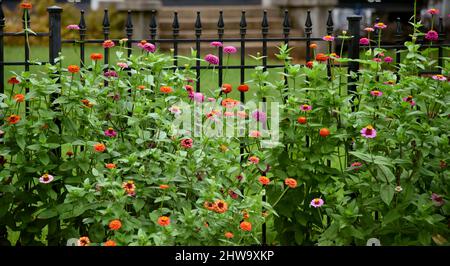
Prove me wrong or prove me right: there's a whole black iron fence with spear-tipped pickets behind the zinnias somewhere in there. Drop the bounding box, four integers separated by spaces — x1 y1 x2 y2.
0 2 449 244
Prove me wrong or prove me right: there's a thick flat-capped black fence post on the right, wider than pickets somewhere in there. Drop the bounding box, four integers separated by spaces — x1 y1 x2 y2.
347 16 362 107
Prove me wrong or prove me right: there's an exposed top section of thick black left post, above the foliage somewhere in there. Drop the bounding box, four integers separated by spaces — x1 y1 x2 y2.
47 6 62 65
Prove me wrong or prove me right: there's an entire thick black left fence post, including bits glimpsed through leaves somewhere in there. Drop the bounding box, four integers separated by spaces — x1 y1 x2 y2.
47 6 62 246
